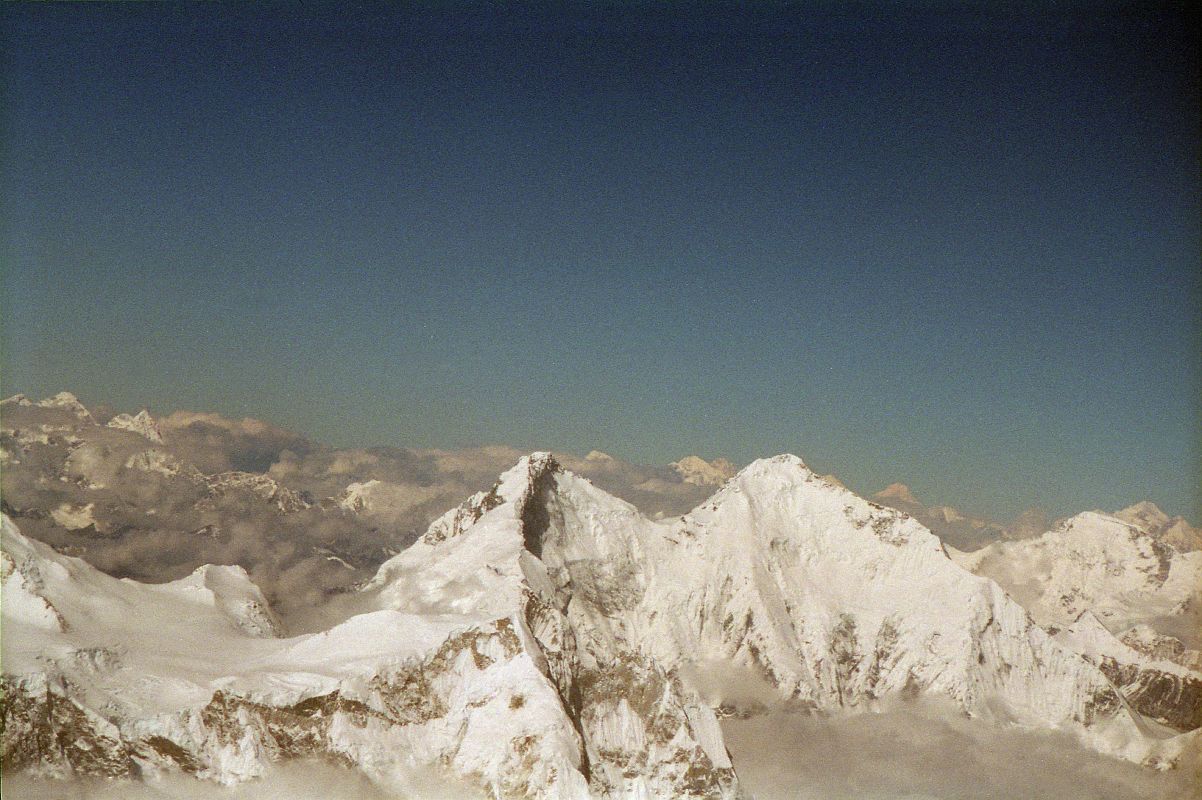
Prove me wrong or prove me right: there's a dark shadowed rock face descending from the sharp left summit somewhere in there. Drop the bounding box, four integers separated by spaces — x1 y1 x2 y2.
519 468 738 798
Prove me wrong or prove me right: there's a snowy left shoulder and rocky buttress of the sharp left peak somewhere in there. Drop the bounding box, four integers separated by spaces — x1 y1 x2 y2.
4 460 737 798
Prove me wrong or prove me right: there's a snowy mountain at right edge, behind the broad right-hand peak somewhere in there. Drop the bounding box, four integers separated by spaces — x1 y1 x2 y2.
950 502 1202 730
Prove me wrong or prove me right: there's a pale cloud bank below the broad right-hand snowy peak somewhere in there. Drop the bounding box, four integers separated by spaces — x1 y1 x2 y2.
722 700 1202 800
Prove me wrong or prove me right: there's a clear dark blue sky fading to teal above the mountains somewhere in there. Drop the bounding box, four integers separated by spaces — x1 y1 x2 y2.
0 2 1202 521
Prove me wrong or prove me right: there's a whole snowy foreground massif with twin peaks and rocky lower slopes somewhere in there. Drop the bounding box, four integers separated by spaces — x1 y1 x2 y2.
2 453 1200 799
